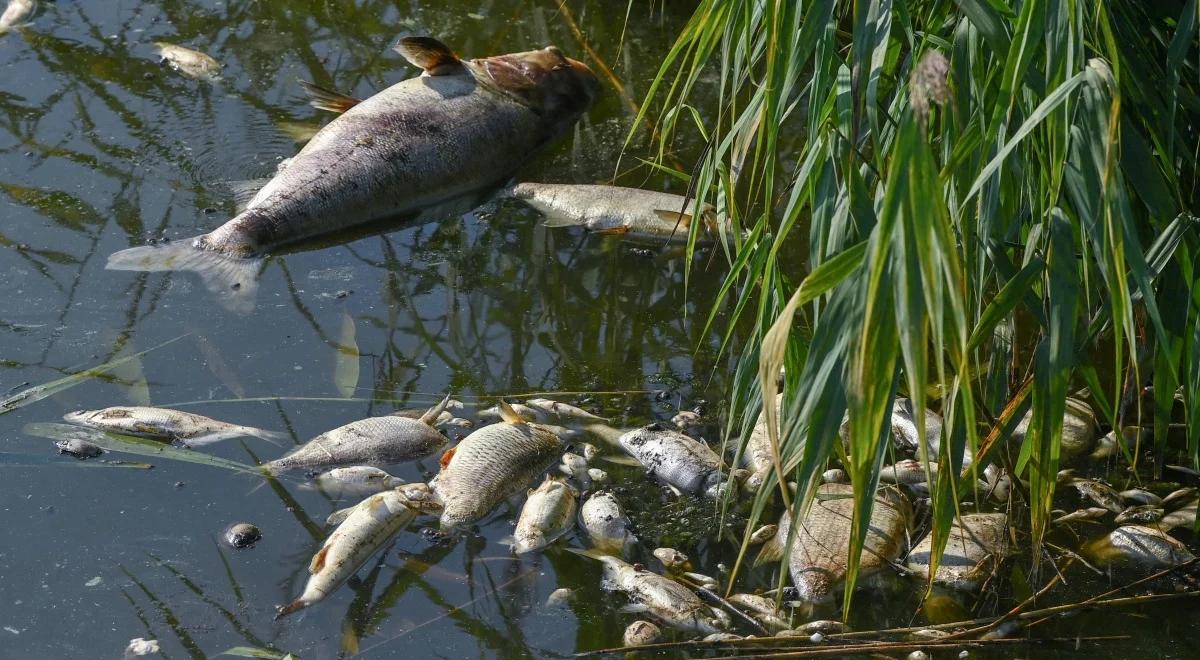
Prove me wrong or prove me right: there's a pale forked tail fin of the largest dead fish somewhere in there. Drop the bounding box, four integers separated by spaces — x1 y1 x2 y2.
104 239 262 313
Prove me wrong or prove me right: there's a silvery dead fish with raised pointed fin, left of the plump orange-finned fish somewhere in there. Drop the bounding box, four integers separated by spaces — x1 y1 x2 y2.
264 402 446 474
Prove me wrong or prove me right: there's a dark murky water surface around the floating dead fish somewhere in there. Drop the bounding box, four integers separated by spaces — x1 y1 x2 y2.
0 0 1198 658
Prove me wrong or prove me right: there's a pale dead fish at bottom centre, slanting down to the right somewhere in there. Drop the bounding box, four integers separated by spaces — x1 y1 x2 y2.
572 550 724 635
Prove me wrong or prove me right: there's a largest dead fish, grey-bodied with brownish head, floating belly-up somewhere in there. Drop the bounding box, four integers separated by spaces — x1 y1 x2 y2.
108 37 598 311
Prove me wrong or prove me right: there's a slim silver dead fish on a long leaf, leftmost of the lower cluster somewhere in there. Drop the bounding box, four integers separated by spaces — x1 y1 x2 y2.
62 406 284 446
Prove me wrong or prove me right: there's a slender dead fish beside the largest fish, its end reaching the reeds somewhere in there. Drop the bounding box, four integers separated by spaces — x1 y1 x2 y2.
505 182 719 245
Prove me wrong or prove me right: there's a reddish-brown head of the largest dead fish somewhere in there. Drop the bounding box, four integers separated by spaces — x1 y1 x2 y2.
473 46 600 124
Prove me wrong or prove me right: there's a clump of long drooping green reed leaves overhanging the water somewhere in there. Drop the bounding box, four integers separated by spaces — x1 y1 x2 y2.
631 0 1200 611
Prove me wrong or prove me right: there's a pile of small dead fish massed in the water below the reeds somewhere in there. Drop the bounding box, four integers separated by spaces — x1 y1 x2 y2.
44 396 1198 644
